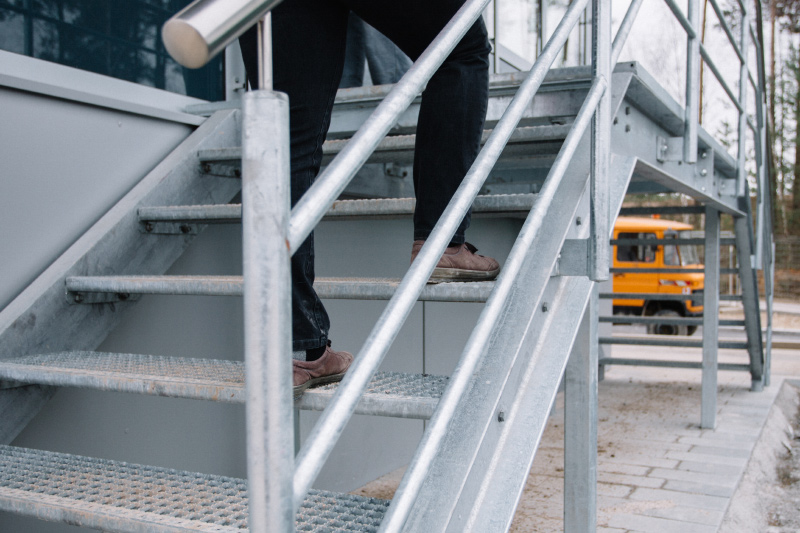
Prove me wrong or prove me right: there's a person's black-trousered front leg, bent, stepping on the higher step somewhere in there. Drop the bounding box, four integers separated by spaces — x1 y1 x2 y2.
343 0 491 244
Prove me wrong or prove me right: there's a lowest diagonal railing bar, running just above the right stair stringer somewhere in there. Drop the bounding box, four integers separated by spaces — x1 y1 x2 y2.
381 75 608 533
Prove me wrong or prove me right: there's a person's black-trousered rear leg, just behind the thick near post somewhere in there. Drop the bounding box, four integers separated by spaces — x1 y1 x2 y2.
240 0 348 359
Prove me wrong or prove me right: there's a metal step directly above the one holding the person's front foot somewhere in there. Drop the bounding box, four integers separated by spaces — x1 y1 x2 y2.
139 194 536 225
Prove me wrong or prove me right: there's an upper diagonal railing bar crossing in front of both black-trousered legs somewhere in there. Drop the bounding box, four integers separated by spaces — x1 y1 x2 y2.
288 0 489 253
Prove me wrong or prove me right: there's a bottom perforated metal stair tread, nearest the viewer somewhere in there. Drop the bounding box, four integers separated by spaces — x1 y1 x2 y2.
0 446 389 532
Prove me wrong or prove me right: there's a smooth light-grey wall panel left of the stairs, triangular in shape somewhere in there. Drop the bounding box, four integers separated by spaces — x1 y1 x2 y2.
0 88 192 307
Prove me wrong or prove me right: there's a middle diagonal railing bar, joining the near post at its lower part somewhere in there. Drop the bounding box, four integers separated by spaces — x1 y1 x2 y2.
294 0 592 505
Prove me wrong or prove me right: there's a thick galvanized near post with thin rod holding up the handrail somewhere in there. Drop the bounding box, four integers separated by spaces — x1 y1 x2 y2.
242 13 294 533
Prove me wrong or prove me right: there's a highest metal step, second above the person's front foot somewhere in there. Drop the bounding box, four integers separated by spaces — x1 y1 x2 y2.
198 124 571 174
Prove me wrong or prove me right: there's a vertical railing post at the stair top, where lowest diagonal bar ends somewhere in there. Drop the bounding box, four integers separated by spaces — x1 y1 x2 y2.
587 0 612 281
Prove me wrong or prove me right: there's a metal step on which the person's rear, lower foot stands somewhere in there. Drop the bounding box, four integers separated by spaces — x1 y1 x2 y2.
0 352 448 419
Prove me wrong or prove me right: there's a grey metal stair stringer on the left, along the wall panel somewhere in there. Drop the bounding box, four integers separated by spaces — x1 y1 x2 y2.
0 110 241 444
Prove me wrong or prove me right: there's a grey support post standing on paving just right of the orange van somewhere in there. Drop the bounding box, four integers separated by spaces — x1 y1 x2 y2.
700 205 720 429
